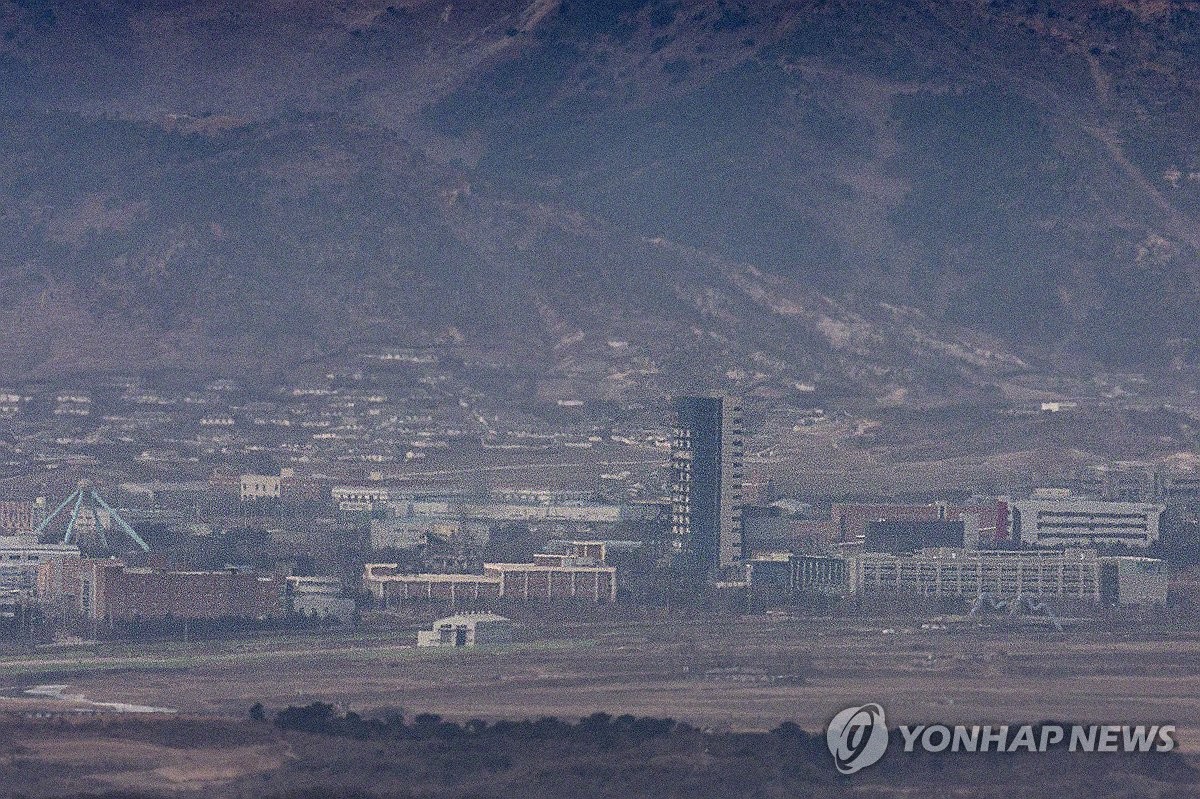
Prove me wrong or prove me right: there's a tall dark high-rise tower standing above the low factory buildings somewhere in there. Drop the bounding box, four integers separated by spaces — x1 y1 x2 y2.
671 397 745 573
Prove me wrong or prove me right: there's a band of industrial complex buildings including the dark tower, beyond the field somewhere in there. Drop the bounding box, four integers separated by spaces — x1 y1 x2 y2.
0 395 1185 639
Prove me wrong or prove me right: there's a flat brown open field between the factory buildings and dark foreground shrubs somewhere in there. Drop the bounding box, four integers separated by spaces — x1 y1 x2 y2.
0 617 1200 751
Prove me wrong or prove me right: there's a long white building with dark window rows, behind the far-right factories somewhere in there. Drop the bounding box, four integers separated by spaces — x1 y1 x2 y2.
1008 495 1165 547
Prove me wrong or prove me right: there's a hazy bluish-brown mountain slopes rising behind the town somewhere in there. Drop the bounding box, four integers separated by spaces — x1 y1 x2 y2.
0 0 1200 395
